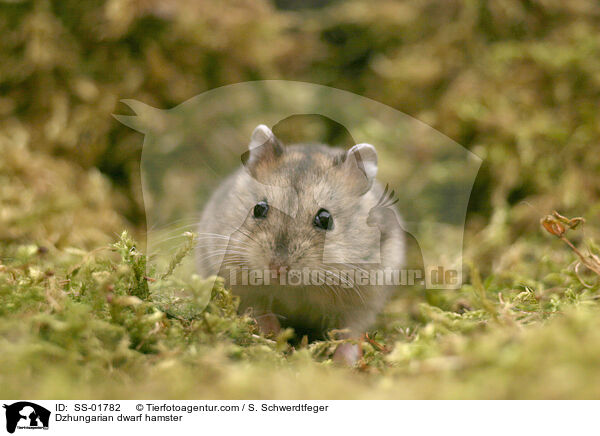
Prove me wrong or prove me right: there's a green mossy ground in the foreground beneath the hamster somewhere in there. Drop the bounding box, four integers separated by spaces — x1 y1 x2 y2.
0 233 600 398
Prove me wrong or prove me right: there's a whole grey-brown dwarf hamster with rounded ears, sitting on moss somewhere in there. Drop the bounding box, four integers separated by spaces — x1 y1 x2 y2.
197 125 405 363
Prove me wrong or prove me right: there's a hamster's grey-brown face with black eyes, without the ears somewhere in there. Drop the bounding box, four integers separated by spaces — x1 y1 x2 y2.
219 123 379 280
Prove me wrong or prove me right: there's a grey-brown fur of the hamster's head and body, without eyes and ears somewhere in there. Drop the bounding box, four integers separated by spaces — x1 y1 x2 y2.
197 126 404 335
